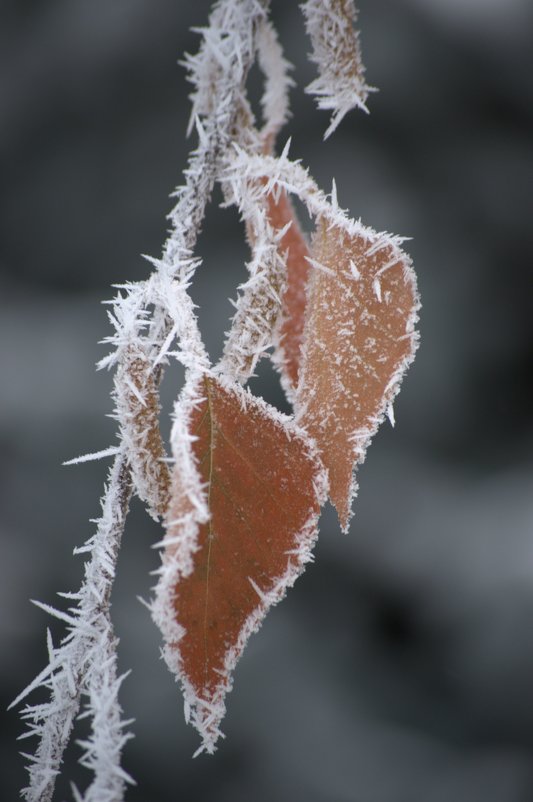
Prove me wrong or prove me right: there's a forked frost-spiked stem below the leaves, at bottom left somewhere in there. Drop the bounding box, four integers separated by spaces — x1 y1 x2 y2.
13 452 131 802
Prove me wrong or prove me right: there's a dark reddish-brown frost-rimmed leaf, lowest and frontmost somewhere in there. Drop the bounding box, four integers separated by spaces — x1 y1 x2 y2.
158 375 326 752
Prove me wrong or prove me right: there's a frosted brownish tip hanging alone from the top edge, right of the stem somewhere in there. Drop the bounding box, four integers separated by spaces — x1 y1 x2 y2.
301 0 373 139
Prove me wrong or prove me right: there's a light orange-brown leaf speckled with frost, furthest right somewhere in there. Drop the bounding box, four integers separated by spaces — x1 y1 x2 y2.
297 220 419 530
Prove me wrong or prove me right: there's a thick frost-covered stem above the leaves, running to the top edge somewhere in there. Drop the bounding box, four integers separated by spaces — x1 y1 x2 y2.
106 0 276 418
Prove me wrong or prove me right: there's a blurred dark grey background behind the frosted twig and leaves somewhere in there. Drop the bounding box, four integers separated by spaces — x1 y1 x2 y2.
0 0 533 802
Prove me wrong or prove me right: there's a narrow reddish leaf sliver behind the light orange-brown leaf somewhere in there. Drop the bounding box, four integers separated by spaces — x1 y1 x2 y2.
268 191 309 393
